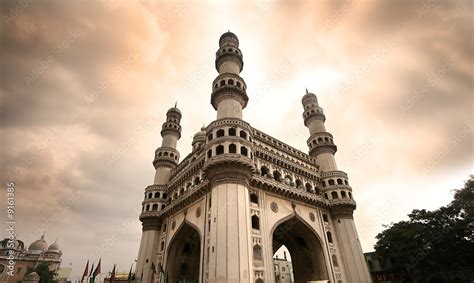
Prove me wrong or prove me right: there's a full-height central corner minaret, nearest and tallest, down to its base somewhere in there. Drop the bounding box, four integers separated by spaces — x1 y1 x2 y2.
203 32 255 283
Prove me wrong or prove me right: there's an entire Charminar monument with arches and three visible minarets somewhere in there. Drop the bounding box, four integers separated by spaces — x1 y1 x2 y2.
135 32 371 283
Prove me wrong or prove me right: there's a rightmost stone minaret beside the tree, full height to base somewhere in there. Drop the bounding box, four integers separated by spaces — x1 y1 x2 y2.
302 90 372 283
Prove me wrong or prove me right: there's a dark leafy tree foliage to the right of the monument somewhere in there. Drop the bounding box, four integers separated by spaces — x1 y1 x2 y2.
375 176 474 275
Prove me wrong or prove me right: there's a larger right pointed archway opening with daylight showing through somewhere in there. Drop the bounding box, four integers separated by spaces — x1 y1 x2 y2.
272 217 329 282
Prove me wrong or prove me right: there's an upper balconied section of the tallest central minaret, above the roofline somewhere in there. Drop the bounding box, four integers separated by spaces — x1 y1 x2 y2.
211 31 249 119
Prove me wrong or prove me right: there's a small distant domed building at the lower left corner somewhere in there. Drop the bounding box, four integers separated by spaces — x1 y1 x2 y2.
0 235 62 282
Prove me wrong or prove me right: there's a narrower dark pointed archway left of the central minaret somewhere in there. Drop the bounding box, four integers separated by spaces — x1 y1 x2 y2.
166 223 201 283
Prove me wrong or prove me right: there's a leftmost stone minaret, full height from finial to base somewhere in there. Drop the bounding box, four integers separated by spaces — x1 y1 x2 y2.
135 104 181 282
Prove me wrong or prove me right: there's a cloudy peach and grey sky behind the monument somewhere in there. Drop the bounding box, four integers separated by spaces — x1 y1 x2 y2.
0 0 474 280
